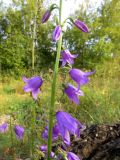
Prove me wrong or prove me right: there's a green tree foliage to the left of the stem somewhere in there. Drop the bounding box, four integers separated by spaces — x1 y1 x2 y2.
0 0 54 76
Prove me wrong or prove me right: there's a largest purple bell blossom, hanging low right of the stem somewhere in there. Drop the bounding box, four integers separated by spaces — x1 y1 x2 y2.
56 111 84 145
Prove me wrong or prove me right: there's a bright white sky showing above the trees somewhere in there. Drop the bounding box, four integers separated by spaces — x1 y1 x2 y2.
3 0 103 20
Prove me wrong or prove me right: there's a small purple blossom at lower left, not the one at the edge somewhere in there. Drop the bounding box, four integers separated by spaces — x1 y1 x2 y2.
14 125 24 140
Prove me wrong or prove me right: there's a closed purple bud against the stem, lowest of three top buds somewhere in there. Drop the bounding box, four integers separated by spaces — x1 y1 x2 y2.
52 25 62 42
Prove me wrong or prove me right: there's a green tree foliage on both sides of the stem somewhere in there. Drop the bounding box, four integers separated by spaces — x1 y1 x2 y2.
0 0 120 77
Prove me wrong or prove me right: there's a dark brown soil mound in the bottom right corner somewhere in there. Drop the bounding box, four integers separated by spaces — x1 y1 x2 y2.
70 124 120 160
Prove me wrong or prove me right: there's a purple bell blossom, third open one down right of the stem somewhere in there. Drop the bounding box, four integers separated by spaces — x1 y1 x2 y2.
64 84 84 105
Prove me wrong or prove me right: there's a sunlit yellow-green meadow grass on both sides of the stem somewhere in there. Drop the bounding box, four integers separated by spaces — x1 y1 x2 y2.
0 58 120 159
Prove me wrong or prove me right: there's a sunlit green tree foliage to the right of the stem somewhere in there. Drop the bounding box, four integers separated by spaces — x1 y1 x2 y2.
65 0 120 68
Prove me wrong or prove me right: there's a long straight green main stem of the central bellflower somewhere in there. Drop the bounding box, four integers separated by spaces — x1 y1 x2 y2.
47 0 62 160
